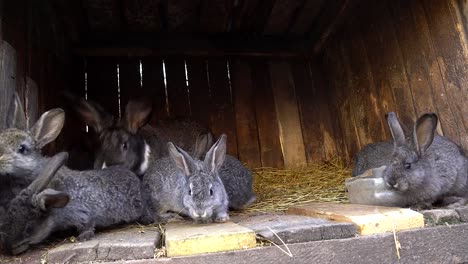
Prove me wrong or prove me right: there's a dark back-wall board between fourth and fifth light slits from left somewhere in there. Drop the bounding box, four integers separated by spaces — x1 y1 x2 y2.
164 58 190 117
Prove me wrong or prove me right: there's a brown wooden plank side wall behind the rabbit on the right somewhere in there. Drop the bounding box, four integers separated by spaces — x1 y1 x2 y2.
323 0 468 162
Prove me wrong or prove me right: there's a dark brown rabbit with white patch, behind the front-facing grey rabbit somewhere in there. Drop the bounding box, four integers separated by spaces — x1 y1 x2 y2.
65 93 212 176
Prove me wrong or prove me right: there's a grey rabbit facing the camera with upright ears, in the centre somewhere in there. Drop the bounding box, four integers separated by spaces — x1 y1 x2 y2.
142 135 229 223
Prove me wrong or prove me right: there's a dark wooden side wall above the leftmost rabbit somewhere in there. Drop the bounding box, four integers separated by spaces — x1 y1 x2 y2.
0 0 71 153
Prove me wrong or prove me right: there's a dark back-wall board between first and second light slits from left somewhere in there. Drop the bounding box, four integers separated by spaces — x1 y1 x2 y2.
86 58 122 117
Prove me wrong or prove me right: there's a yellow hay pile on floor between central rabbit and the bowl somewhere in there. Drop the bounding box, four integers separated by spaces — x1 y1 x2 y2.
243 158 351 213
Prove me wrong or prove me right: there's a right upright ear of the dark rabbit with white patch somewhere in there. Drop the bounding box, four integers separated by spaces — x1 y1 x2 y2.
124 100 152 134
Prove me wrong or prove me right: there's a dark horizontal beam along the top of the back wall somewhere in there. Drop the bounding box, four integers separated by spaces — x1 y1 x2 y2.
74 36 307 58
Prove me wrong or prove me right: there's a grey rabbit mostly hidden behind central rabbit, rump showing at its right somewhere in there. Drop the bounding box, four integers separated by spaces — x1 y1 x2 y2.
195 135 256 210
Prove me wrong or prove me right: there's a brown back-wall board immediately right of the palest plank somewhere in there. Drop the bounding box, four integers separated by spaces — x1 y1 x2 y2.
291 62 328 162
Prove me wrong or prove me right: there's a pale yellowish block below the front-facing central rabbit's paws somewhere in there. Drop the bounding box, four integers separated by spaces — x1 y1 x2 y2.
165 221 257 257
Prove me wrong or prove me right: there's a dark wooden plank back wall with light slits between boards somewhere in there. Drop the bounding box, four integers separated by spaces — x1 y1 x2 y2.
81 57 340 168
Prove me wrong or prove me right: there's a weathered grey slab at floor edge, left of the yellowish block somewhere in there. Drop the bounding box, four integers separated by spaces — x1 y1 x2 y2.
47 228 160 263
